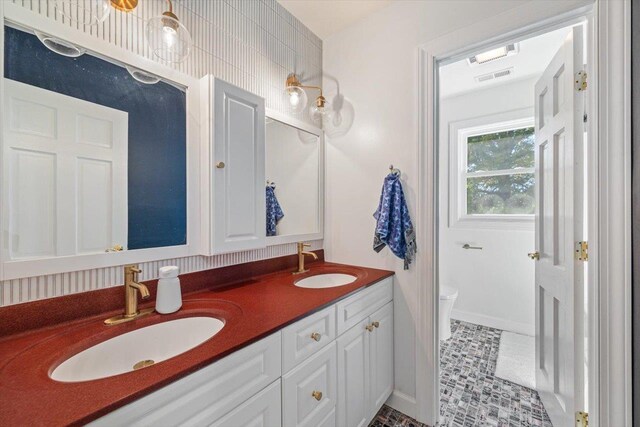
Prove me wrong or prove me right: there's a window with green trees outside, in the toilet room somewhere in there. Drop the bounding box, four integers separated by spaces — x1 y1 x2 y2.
464 126 535 215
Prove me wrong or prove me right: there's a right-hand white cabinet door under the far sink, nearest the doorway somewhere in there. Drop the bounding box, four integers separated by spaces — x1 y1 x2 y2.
369 302 393 416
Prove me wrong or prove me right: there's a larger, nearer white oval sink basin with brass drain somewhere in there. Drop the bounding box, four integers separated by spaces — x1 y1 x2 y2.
51 317 224 382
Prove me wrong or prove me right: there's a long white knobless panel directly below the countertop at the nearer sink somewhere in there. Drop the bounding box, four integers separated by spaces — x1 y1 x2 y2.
92 332 282 426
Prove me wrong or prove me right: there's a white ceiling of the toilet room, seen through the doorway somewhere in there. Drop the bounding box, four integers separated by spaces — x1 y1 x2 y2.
440 28 571 97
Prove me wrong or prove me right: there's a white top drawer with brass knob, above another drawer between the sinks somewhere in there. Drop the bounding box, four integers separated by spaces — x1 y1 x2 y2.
282 306 336 373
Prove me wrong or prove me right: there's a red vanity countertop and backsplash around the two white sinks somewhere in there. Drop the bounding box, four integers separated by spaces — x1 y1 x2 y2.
0 252 393 426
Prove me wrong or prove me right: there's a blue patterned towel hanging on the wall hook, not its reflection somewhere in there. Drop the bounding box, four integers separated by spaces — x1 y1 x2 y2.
373 173 416 270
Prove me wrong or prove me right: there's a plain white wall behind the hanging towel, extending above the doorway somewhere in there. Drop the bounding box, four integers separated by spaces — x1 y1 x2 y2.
323 0 587 415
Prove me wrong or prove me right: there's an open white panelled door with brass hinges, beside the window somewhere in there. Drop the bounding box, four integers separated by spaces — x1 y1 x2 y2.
530 27 584 427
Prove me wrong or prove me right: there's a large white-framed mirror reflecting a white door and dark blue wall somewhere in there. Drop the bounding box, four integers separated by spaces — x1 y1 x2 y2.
0 5 200 280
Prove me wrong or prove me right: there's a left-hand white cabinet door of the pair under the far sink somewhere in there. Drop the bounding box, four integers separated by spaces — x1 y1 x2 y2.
336 319 371 427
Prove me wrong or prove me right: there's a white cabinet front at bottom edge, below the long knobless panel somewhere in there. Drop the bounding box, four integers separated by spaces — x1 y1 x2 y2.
211 380 282 427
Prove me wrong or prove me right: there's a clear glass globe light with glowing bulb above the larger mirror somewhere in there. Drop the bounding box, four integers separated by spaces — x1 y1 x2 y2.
146 0 193 63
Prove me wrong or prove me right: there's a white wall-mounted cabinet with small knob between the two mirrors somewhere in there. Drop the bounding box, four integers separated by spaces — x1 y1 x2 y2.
202 76 266 254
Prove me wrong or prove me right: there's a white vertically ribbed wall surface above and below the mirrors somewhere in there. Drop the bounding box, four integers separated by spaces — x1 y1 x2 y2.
0 0 323 306
